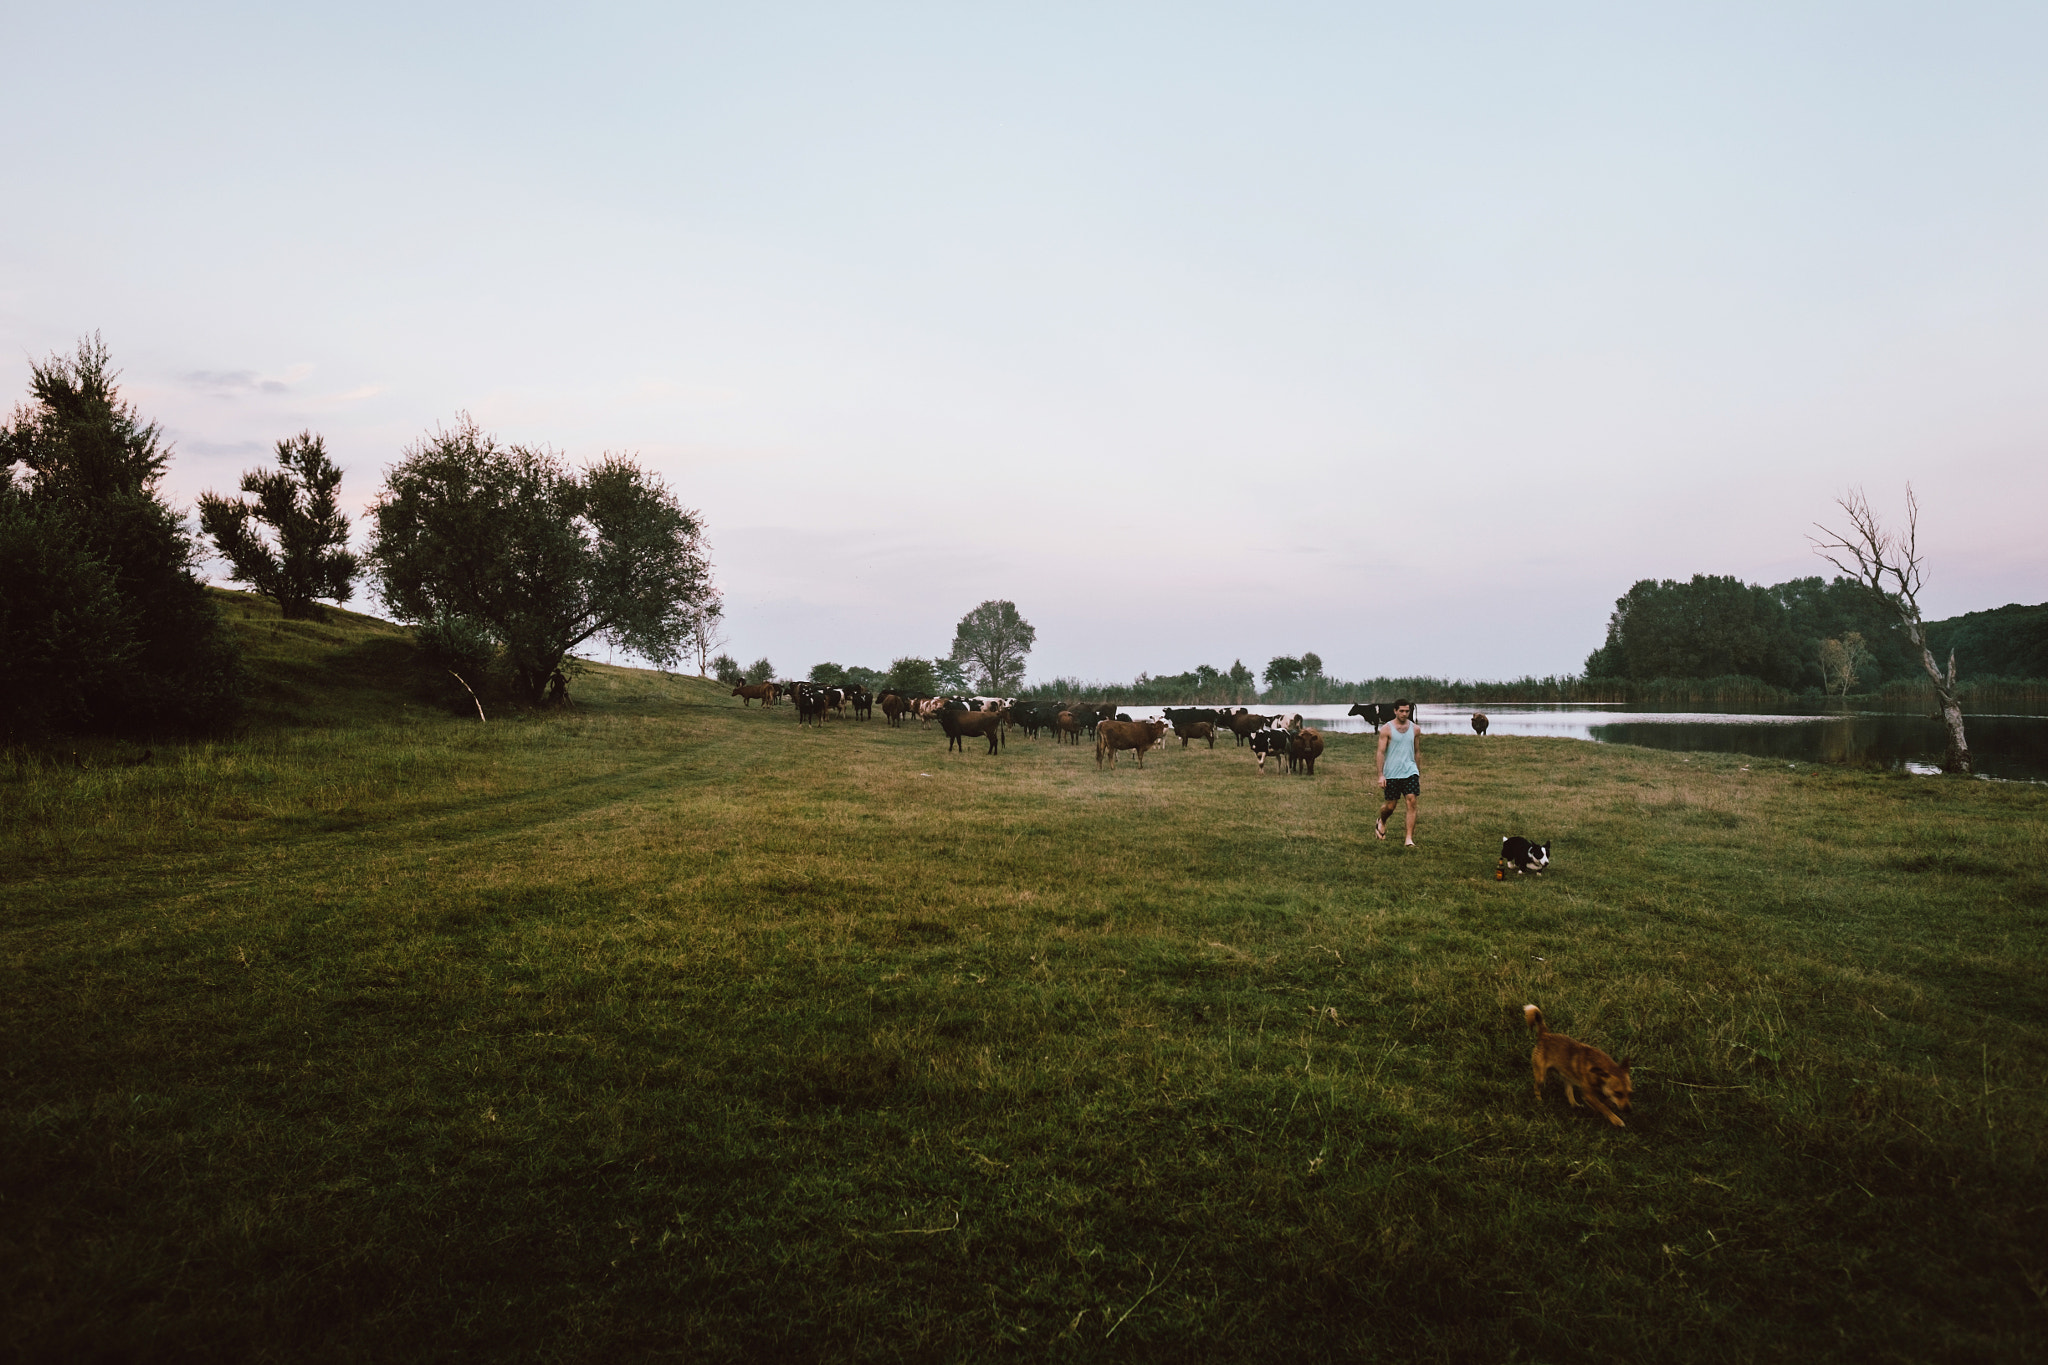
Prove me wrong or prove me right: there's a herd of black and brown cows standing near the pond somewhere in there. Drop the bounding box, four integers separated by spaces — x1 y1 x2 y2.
733 681 1487 778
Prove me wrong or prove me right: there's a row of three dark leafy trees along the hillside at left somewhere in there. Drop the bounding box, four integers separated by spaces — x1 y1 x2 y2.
0 336 721 739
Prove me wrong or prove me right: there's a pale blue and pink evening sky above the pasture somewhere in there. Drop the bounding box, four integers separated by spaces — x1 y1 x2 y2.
0 0 2048 679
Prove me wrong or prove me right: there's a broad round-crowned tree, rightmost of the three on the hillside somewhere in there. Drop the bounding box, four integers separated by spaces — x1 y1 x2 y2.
369 417 711 704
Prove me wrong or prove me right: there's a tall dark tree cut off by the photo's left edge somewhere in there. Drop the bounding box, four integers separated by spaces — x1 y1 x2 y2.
0 336 244 733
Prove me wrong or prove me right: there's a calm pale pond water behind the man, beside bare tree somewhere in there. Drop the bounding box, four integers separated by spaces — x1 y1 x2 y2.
1124 702 2048 782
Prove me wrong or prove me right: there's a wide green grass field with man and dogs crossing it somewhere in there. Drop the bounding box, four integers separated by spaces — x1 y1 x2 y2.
12 598 2048 1361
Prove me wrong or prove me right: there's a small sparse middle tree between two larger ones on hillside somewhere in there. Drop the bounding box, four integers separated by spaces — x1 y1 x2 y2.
199 432 358 620
